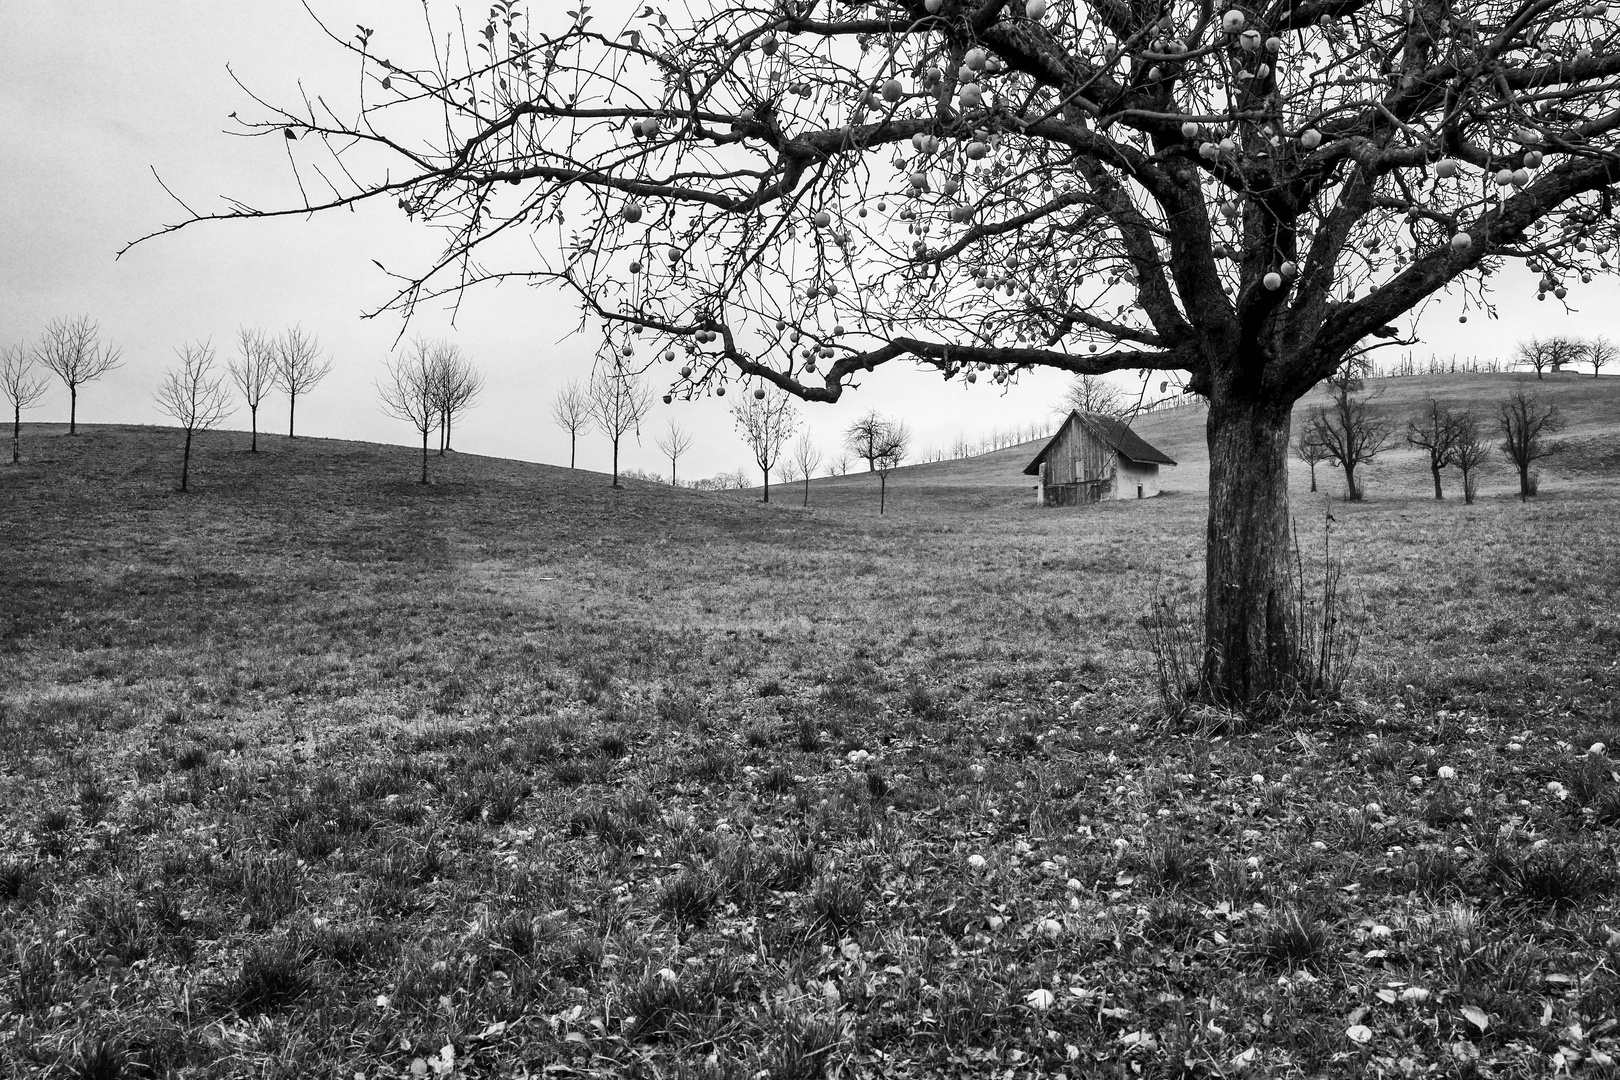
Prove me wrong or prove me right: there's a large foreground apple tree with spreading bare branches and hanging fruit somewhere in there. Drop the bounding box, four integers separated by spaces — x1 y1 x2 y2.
126 0 1620 704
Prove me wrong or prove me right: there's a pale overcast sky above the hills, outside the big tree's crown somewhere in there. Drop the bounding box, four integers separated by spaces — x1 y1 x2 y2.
0 0 1617 476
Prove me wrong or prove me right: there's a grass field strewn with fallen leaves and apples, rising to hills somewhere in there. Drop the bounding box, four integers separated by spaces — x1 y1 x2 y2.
0 376 1620 1078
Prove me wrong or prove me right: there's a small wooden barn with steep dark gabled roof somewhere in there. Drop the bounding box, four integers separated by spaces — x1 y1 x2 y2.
1024 413 1175 507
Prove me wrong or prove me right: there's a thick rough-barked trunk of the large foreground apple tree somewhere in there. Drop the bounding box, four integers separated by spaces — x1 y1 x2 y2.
1200 389 1301 704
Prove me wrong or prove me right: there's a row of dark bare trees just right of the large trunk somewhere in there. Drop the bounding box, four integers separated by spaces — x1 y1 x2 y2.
1294 372 1563 504
